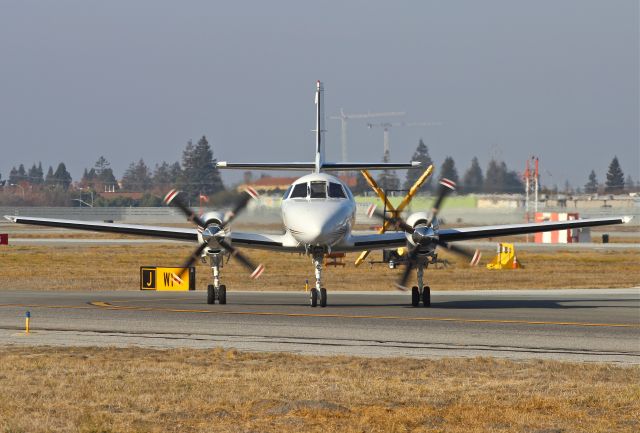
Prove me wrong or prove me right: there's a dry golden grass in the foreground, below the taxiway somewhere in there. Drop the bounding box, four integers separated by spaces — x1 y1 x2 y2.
0 348 640 433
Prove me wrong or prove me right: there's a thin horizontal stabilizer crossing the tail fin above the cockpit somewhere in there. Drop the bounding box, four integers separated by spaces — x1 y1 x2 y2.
216 161 422 171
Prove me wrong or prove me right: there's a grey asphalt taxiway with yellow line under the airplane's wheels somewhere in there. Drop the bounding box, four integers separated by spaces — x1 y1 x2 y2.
0 288 640 364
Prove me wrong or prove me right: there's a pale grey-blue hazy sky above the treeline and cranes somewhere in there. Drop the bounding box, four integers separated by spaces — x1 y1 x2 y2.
0 0 640 186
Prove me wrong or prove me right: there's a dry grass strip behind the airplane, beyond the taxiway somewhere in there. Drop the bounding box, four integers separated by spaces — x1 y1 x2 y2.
0 244 640 290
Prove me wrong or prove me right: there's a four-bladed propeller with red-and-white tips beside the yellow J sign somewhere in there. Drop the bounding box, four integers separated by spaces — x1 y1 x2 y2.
164 187 264 279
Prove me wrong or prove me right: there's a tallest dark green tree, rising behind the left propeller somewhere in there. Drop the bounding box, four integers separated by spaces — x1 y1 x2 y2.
181 136 224 199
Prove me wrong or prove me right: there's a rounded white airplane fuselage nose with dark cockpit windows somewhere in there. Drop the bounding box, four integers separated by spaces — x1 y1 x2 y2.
282 173 356 250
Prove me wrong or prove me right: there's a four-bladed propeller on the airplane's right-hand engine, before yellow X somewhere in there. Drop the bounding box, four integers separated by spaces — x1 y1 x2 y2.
367 178 481 291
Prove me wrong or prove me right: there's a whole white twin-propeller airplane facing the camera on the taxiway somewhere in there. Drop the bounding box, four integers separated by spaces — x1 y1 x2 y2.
5 81 631 307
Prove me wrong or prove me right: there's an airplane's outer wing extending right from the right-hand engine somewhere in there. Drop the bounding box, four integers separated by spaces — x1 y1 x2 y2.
438 217 631 242
